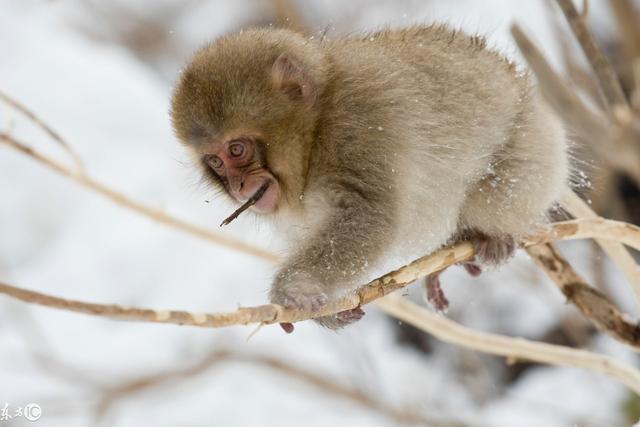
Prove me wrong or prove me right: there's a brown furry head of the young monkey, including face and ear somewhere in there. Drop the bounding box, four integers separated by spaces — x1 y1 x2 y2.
171 29 328 213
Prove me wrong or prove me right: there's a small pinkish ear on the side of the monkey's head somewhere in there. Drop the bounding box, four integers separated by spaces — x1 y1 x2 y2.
271 53 316 105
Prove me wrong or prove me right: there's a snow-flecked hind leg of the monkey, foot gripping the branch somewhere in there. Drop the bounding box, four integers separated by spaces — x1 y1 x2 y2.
460 103 568 266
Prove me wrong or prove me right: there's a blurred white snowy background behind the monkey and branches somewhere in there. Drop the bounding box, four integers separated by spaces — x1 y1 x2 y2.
0 0 638 427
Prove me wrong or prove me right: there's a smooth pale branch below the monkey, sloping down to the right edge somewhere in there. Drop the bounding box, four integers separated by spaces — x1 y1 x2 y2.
376 294 640 395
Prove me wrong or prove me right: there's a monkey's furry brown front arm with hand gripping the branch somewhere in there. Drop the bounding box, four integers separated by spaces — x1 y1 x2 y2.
271 183 395 332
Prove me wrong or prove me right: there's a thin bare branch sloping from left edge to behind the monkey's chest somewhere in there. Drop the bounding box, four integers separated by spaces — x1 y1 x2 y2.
0 133 278 262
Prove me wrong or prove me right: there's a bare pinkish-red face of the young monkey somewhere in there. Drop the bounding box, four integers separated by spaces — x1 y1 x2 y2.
202 137 280 213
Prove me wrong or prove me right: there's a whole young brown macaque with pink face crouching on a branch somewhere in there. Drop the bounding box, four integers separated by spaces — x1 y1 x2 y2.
172 26 568 329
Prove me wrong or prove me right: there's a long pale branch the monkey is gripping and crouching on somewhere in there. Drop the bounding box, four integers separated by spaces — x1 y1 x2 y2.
0 220 640 348
